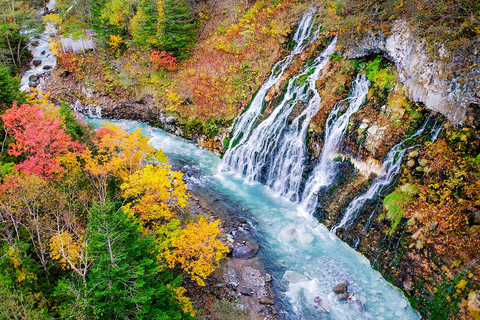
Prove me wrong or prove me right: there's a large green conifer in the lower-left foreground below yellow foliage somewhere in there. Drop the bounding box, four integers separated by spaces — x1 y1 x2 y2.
58 203 191 319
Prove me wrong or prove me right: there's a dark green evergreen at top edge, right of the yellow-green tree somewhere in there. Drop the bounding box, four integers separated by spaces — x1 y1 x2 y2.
162 0 195 59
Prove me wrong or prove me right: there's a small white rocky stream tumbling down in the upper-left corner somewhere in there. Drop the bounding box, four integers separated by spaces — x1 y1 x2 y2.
20 0 57 91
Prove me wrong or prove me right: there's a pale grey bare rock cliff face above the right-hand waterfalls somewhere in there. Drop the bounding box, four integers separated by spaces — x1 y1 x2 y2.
344 21 480 125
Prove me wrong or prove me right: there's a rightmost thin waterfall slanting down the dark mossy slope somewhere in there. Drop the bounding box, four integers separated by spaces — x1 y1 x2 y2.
331 118 430 234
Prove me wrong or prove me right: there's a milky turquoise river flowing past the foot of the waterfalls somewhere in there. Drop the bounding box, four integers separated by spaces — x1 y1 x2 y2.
87 119 420 320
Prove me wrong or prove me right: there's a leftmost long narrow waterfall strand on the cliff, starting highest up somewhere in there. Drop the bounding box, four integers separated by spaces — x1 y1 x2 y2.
221 7 318 174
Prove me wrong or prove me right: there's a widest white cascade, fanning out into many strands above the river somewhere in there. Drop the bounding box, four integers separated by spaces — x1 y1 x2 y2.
226 38 336 201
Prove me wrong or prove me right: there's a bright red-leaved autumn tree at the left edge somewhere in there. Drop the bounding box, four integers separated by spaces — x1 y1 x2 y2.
1 103 83 179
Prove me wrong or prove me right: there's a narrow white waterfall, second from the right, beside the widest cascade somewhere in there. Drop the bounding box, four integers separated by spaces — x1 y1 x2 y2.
302 75 370 213
